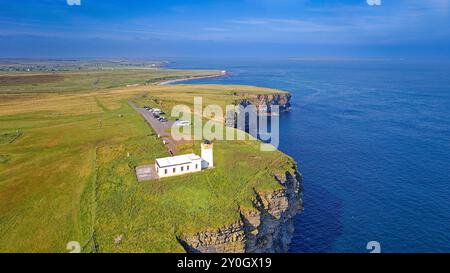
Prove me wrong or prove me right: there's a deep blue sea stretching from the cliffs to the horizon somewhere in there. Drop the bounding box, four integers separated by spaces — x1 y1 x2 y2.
170 60 450 252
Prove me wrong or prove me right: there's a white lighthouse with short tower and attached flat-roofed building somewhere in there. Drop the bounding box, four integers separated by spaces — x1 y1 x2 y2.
155 141 214 178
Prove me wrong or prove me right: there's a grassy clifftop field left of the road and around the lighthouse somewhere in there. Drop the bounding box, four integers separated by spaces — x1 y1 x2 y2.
0 69 295 252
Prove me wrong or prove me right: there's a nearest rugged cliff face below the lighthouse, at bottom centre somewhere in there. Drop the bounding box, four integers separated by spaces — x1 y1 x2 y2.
180 169 303 253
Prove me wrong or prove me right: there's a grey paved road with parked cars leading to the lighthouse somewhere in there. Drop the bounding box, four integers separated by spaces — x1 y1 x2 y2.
128 98 177 155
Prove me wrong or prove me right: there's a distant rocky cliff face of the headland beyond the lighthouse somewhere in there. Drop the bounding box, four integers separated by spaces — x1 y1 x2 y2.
234 93 291 111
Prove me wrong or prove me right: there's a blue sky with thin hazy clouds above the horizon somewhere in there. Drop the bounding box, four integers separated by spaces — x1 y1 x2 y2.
0 0 450 59
